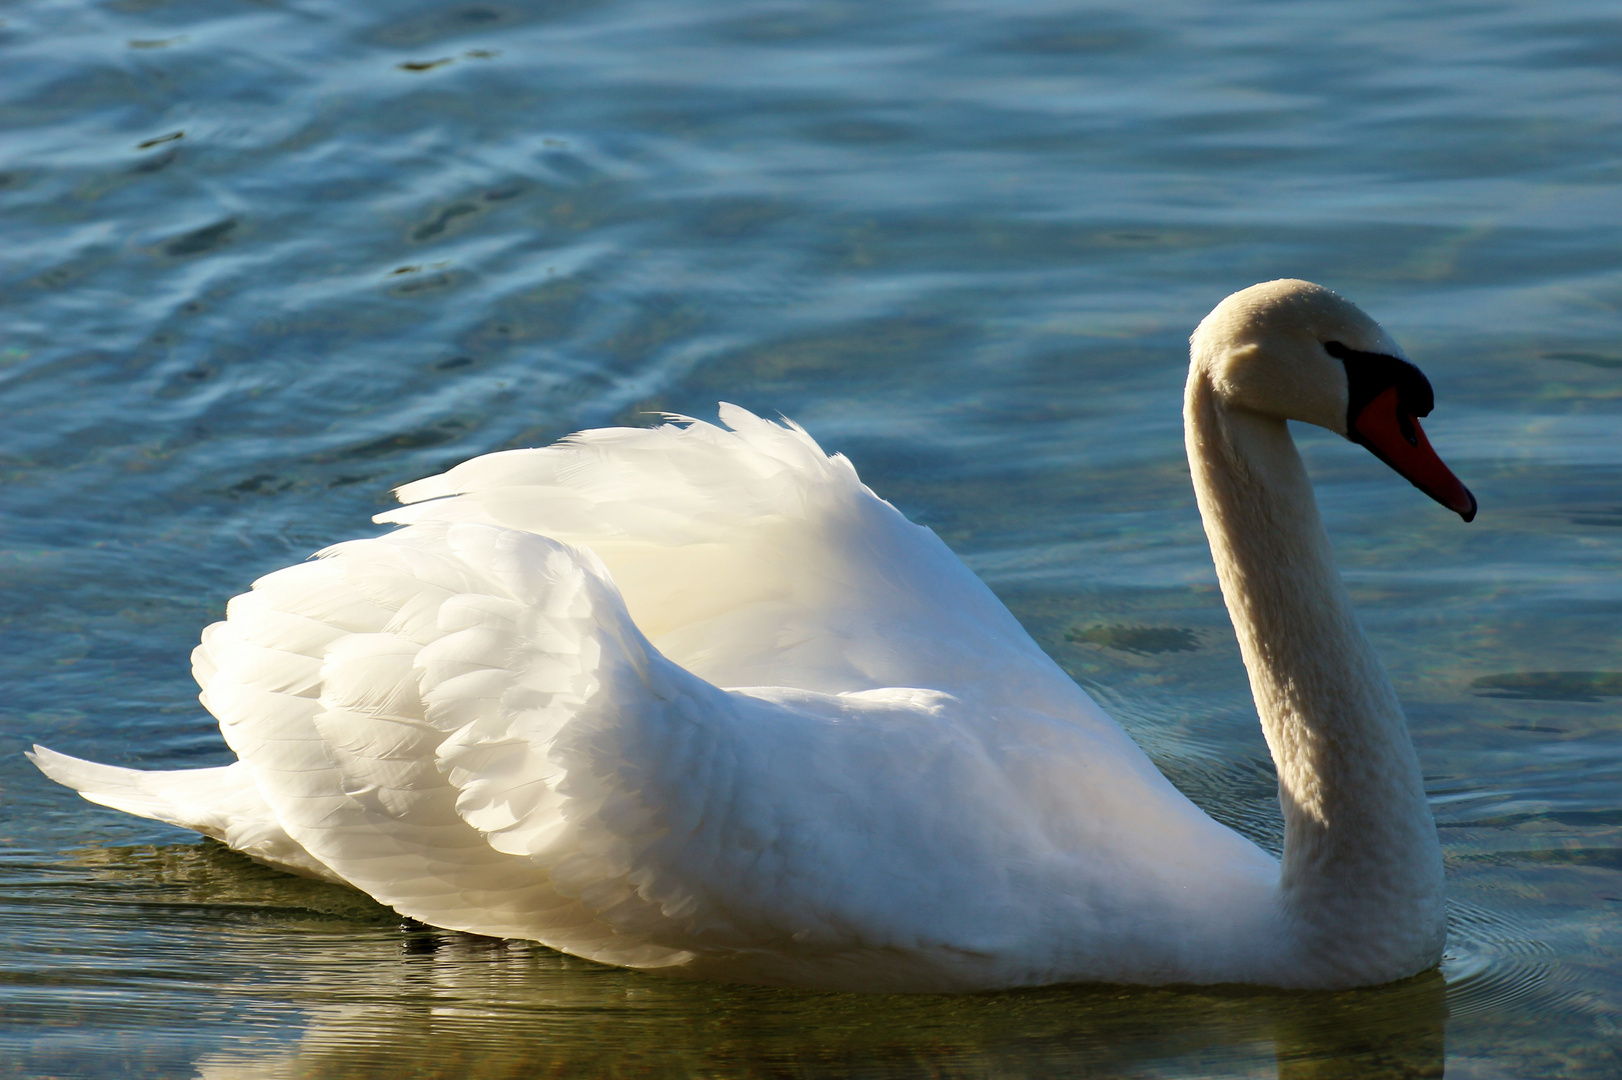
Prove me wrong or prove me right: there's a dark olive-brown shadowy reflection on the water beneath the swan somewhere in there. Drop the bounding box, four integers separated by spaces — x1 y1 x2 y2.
13 843 1447 1080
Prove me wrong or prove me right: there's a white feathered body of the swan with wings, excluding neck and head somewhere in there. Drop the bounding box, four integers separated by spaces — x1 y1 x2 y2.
42 409 1277 989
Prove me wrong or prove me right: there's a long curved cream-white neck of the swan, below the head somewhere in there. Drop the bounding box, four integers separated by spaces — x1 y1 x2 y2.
1184 365 1445 983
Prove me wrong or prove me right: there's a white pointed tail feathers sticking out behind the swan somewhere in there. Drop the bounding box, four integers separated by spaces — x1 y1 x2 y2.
28 746 344 884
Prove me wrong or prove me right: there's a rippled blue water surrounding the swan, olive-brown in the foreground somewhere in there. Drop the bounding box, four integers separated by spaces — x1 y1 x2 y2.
0 0 1622 1078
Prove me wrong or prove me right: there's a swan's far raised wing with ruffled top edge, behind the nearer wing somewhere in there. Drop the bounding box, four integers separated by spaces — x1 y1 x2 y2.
378 398 1083 710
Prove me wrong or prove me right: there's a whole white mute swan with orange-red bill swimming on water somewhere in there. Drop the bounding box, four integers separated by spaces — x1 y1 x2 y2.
34 281 1476 991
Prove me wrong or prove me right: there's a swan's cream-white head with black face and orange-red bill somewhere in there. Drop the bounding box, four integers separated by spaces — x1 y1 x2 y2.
1191 279 1476 521
